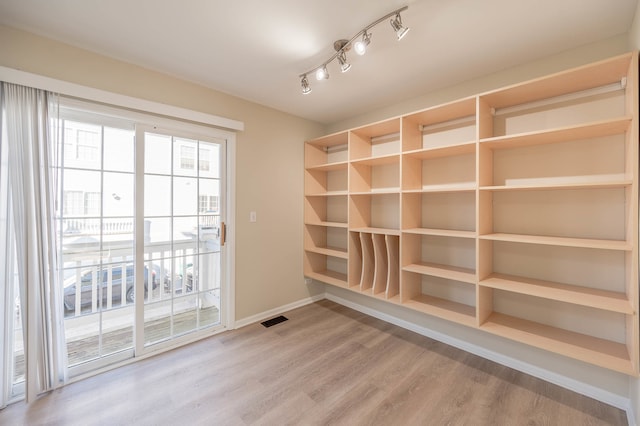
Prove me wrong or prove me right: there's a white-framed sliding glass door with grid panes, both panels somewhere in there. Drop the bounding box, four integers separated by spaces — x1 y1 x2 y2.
57 105 226 376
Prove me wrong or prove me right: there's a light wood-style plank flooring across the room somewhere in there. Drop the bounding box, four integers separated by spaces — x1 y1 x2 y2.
0 300 627 426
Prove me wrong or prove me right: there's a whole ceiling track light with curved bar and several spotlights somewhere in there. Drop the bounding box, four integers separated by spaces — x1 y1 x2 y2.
300 6 409 95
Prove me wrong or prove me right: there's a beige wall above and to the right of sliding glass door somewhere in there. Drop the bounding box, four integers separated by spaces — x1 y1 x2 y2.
0 26 324 320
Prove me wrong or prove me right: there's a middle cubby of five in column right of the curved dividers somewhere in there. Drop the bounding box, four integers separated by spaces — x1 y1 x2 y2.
402 190 476 238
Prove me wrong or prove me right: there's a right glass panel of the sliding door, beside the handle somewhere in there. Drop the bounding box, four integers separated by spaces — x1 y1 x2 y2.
143 132 224 346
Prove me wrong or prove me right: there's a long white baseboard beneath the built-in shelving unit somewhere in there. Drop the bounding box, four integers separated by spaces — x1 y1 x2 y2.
326 293 635 414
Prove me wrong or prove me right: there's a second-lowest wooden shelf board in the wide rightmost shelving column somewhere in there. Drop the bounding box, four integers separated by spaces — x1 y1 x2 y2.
479 274 634 315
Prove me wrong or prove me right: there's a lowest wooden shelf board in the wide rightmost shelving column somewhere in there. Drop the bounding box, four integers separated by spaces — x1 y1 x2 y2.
480 312 635 374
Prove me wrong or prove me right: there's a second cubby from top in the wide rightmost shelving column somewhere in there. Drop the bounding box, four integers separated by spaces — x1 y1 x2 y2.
479 117 635 189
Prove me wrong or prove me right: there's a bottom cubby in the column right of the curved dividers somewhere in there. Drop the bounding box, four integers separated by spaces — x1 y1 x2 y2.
401 269 476 326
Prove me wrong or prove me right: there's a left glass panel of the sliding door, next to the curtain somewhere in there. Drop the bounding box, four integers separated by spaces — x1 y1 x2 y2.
57 115 136 371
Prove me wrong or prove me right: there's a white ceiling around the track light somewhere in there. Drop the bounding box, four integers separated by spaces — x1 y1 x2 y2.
0 0 638 123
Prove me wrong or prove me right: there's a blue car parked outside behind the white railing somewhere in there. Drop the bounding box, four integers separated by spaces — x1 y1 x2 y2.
64 263 164 311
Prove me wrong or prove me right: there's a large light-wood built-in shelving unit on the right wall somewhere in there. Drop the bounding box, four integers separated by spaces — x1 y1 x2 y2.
304 53 640 375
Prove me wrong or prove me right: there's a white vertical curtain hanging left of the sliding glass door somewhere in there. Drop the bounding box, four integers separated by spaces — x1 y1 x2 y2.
0 82 66 405
